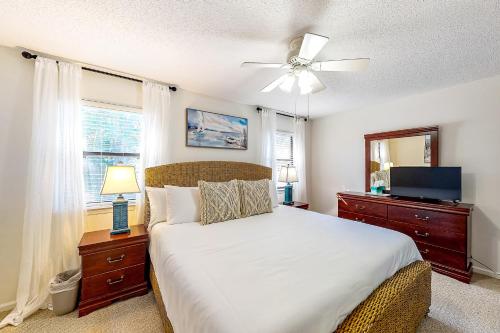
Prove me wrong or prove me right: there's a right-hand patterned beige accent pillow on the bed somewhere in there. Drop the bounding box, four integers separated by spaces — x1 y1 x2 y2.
238 179 273 217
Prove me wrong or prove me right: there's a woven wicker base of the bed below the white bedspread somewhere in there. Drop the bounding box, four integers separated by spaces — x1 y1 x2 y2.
149 261 431 333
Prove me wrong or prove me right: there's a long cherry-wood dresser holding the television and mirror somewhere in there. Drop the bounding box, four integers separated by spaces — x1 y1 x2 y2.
337 192 473 283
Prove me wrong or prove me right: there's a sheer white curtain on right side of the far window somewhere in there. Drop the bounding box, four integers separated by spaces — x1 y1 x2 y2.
293 118 307 202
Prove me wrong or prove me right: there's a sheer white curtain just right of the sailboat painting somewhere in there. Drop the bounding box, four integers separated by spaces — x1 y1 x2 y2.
260 108 278 182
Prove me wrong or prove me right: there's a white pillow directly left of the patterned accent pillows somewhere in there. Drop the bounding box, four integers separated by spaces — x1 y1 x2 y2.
165 185 201 224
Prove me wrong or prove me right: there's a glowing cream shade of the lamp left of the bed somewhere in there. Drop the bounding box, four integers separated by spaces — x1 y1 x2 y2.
101 165 141 194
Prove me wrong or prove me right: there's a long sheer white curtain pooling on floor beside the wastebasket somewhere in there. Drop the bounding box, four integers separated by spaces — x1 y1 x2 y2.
0 57 84 327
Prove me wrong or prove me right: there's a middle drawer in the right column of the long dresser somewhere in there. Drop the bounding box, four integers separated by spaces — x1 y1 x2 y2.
387 221 467 253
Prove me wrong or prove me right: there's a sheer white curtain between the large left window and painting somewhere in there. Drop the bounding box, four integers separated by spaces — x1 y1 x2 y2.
136 81 171 223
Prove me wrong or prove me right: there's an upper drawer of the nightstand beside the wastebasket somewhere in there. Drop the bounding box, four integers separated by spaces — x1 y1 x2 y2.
82 243 146 278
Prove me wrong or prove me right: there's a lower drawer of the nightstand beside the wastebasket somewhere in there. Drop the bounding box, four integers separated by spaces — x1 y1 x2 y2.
81 263 146 301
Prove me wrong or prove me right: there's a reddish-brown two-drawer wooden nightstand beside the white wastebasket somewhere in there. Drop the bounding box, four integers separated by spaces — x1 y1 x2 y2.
78 224 148 317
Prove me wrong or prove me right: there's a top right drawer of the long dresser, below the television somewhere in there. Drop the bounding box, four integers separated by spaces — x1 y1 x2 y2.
387 206 467 234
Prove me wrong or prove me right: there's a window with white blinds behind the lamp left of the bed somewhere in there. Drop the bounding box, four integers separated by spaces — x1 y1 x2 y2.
82 105 142 205
